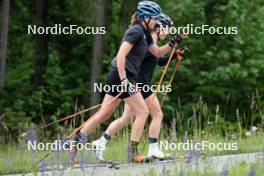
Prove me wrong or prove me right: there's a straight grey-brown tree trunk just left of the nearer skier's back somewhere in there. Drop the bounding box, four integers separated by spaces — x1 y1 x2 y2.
90 0 106 106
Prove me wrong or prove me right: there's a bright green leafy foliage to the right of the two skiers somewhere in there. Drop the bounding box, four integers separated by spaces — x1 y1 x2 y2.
156 0 264 128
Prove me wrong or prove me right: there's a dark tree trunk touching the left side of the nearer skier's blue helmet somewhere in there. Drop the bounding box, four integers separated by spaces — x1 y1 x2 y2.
120 0 139 34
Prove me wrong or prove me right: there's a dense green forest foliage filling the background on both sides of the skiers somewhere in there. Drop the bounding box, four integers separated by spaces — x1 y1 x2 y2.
2 0 264 140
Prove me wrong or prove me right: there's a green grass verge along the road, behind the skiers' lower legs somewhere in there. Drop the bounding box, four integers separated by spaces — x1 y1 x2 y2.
0 129 264 175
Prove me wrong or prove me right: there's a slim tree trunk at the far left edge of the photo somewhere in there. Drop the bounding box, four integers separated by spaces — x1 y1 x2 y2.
0 0 10 115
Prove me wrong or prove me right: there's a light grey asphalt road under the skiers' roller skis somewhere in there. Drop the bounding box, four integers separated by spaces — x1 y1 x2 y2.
5 153 264 176
